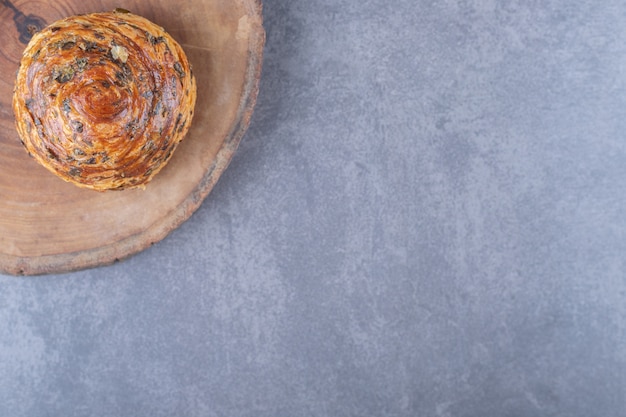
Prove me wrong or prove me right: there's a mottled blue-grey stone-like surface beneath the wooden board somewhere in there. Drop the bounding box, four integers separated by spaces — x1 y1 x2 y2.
0 0 626 417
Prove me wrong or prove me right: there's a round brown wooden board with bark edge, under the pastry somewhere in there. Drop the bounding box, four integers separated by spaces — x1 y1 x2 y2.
0 0 265 275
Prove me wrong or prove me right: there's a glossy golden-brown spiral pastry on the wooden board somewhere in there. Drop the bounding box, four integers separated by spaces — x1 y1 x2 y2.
13 9 196 190
